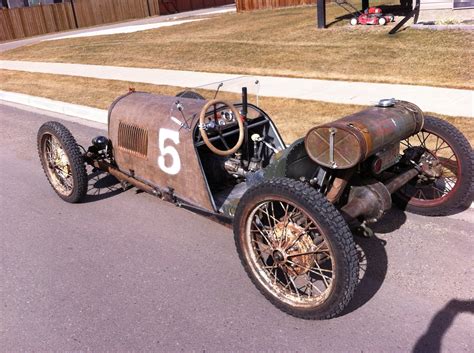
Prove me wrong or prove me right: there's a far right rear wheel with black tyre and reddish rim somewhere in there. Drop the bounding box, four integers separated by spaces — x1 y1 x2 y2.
394 116 474 216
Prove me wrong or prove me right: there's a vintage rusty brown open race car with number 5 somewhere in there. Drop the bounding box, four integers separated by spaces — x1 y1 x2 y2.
38 87 473 319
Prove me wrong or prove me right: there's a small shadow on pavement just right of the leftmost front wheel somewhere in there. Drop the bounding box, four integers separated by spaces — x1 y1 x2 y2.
82 170 123 203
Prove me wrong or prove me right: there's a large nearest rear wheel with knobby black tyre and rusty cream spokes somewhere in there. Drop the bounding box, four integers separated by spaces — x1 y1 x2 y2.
234 178 358 319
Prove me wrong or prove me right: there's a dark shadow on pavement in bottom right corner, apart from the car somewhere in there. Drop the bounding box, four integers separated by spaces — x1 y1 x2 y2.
412 299 474 353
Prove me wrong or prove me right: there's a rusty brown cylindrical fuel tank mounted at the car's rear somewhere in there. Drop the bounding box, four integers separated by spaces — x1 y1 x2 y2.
305 100 424 169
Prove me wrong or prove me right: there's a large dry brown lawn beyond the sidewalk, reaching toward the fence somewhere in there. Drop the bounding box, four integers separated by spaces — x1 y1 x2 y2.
0 0 474 88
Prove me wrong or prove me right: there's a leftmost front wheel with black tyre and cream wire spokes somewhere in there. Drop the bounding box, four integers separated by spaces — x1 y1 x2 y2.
37 121 87 203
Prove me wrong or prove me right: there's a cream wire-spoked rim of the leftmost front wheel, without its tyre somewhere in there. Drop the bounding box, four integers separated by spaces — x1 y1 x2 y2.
42 134 74 196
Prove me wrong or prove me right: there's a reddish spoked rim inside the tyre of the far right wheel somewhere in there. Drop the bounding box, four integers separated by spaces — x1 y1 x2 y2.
399 131 461 206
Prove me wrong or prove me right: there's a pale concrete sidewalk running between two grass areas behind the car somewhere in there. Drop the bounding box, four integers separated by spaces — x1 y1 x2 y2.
0 60 474 117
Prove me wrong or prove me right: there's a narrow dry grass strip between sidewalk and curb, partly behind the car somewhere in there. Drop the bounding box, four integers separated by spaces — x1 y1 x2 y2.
0 70 474 144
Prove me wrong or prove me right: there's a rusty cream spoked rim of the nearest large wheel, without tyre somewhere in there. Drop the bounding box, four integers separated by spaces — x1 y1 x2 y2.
244 197 336 308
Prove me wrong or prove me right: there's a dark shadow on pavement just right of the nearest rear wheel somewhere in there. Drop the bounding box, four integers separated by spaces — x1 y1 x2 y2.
343 208 407 315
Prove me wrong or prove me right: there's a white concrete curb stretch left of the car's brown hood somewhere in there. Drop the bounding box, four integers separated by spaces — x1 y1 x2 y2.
0 90 107 124
